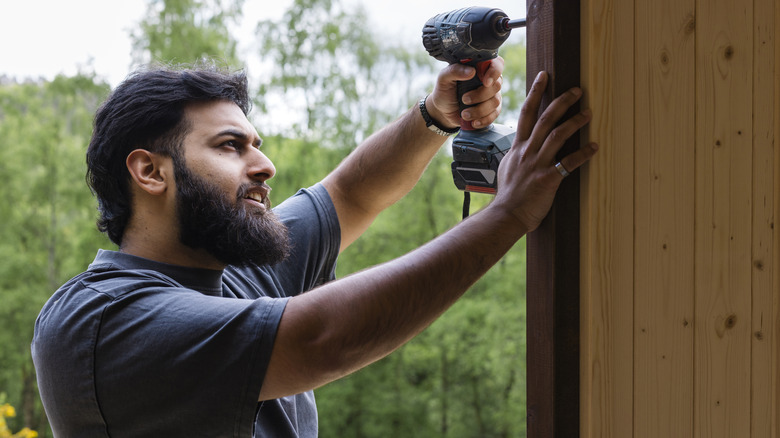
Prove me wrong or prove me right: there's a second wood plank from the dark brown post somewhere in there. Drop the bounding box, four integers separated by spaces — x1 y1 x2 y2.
634 0 697 438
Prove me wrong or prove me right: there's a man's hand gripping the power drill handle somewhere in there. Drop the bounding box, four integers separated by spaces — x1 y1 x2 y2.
426 56 504 128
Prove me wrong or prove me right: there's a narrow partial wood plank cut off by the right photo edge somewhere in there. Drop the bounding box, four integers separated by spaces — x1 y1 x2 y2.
750 0 780 438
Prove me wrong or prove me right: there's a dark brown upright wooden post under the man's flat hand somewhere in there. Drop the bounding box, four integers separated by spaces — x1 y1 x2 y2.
527 0 580 438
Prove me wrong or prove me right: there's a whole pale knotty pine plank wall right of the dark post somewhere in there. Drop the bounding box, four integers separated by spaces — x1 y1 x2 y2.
576 0 780 438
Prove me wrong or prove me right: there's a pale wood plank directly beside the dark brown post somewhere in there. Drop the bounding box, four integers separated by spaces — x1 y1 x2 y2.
580 0 634 438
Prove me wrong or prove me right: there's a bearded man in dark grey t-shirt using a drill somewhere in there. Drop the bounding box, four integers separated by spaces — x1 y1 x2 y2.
32 58 596 437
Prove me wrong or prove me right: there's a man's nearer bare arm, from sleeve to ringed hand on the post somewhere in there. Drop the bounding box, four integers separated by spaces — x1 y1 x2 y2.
260 75 596 400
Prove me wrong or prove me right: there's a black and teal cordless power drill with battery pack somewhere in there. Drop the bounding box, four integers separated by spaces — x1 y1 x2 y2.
422 6 526 201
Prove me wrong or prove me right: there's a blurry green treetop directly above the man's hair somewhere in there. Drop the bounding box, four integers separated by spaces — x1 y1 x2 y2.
131 0 244 68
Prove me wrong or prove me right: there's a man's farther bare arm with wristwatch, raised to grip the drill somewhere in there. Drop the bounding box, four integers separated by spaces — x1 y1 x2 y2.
322 57 504 250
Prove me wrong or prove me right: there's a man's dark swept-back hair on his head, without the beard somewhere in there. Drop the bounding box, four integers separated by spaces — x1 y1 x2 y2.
87 64 251 245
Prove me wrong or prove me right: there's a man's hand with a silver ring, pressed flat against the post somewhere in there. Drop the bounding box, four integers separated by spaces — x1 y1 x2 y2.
491 72 598 232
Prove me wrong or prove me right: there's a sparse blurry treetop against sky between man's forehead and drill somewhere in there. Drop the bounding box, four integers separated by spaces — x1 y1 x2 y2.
257 0 435 147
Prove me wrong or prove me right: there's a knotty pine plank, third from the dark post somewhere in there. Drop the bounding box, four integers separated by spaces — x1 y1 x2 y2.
694 0 754 438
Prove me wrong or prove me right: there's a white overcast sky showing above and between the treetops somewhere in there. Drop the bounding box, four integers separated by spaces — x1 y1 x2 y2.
0 0 525 85
